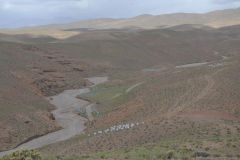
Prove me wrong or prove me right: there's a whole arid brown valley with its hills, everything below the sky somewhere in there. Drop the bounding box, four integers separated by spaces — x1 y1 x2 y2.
0 4 240 160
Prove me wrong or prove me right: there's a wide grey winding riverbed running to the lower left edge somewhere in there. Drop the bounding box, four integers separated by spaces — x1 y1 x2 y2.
0 77 108 158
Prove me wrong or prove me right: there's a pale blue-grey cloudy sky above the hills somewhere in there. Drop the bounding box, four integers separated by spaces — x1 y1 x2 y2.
0 0 240 28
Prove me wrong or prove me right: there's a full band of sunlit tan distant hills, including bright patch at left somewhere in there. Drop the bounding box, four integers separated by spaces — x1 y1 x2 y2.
0 8 240 39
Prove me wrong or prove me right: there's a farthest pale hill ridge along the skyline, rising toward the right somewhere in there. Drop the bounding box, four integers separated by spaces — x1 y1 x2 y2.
19 8 240 30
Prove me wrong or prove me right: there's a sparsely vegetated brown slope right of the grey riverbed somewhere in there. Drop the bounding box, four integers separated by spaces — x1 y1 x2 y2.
37 55 240 159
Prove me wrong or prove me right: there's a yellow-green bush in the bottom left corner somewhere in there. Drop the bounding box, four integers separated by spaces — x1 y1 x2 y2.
2 149 42 160
